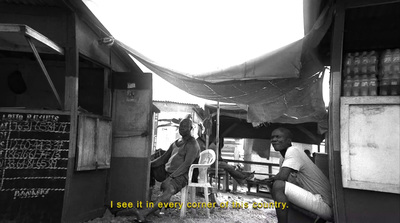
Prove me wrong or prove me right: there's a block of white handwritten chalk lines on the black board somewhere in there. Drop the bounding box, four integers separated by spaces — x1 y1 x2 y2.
0 113 70 199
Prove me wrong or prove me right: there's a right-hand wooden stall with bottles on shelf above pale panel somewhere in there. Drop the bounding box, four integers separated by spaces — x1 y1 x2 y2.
329 0 400 222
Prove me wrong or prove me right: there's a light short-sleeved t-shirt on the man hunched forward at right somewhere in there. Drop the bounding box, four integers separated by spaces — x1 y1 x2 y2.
281 147 332 207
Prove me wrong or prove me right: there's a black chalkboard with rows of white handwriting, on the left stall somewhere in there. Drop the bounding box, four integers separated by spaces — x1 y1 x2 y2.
0 112 70 222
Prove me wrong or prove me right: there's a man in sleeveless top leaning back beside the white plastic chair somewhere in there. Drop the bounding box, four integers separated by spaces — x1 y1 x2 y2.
133 119 200 222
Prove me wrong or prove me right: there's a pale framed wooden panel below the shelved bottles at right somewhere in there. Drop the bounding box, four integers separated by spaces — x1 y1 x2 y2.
340 96 400 194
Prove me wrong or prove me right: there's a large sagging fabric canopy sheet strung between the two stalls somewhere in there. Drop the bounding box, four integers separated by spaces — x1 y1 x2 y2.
116 2 333 127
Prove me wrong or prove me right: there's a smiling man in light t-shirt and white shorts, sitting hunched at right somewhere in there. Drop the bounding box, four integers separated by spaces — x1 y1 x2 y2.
267 128 332 223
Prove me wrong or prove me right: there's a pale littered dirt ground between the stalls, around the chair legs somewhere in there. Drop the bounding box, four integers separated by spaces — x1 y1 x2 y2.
88 185 278 223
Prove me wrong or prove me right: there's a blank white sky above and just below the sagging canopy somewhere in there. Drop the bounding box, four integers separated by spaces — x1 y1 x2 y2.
84 0 304 104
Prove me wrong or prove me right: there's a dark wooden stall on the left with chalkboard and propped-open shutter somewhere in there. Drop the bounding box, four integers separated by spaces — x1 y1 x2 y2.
0 0 152 222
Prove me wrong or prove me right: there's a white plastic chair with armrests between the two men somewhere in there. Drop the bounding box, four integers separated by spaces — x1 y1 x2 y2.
180 149 216 218
